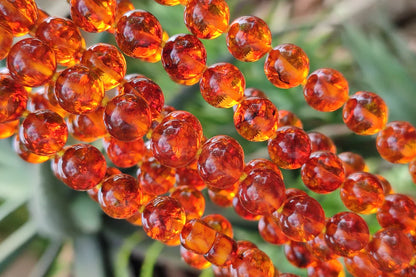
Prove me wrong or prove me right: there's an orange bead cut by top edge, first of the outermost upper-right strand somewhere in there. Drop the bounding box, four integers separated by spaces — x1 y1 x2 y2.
183 0 230 39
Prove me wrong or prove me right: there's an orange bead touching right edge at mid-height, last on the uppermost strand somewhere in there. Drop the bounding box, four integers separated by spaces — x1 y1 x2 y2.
376 121 416 164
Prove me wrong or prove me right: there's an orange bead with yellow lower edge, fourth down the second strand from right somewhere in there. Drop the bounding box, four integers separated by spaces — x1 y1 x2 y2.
199 63 246 108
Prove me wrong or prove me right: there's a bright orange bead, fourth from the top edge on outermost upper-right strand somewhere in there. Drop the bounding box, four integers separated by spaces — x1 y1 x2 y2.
303 68 349 112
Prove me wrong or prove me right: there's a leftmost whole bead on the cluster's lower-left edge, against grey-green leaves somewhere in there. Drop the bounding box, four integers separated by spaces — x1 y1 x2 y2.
19 110 68 156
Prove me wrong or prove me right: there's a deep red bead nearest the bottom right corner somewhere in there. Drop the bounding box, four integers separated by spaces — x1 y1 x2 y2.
367 228 414 272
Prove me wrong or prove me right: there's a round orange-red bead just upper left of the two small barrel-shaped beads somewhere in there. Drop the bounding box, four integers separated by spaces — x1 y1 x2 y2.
142 196 186 242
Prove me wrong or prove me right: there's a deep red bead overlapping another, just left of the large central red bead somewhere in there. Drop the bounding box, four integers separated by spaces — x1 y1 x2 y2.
104 94 152 141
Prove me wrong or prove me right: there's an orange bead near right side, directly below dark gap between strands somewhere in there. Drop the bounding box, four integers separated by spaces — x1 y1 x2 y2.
340 172 384 214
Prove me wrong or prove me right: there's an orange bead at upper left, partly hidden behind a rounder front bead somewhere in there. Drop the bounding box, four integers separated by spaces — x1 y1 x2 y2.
36 17 85 67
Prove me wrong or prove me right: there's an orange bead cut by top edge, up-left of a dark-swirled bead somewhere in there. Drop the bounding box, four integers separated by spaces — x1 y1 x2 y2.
71 0 117 33
